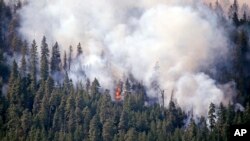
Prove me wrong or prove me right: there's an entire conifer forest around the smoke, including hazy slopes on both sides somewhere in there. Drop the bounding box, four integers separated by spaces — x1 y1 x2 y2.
0 0 250 141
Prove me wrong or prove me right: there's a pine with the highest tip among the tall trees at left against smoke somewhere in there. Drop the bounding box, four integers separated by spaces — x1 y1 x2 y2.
40 36 49 81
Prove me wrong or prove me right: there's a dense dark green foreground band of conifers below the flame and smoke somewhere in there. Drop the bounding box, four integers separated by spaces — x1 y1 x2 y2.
0 61 250 141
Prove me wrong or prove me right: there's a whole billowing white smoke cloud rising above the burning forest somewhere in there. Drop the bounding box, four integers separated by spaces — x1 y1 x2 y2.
19 0 233 116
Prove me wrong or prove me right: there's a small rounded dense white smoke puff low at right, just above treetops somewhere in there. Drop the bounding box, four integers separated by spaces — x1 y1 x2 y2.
175 73 236 115
